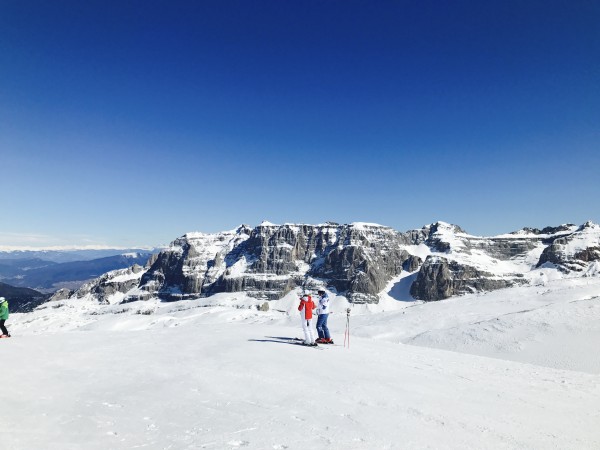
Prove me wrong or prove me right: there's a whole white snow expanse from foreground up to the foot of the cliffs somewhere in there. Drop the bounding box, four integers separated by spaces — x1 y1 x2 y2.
0 274 600 450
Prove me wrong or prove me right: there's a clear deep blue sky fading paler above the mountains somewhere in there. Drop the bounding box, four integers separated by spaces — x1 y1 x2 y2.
0 0 600 246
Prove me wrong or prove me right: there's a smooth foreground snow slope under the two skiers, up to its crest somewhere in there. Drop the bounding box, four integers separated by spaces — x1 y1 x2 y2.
1 323 600 449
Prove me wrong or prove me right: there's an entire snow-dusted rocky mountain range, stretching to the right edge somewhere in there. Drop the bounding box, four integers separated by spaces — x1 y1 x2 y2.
63 222 600 303
